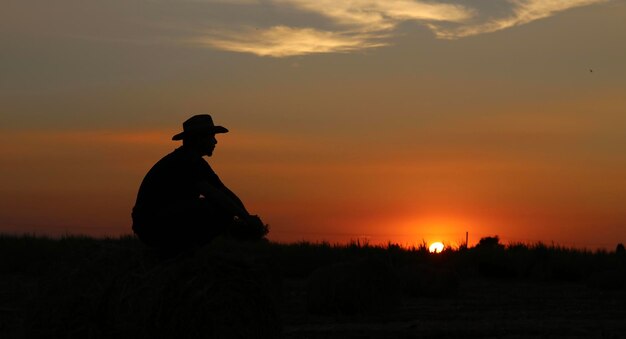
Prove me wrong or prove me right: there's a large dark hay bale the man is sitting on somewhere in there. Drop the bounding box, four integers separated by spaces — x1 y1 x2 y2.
100 239 281 339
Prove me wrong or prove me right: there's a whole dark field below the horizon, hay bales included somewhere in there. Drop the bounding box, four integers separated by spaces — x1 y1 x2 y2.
0 236 626 338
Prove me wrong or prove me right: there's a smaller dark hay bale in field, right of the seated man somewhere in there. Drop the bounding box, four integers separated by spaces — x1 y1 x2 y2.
307 259 399 315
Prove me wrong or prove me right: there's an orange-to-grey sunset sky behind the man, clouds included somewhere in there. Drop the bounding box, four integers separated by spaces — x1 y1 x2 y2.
0 0 626 248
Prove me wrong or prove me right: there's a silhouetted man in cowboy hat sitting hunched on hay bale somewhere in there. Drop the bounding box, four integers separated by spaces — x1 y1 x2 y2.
132 114 267 252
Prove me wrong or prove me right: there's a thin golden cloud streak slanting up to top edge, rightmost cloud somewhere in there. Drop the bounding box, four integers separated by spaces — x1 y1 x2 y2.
427 0 609 39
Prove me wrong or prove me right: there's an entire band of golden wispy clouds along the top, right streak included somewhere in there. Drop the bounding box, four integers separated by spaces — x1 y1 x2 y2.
192 0 610 57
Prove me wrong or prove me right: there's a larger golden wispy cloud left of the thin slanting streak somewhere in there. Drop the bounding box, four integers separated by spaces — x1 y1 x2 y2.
193 0 473 57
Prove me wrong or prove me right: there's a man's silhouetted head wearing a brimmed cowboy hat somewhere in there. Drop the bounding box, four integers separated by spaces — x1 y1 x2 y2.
172 114 228 156
